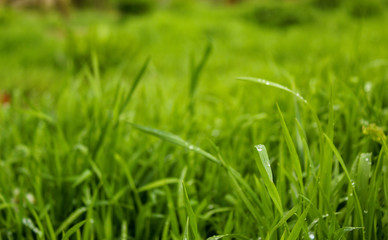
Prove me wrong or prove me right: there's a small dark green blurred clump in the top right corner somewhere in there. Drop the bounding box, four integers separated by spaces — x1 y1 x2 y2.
349 0 384 18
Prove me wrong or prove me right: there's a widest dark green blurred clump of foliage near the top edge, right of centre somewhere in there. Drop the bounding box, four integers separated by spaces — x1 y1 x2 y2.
250 2 313 28
